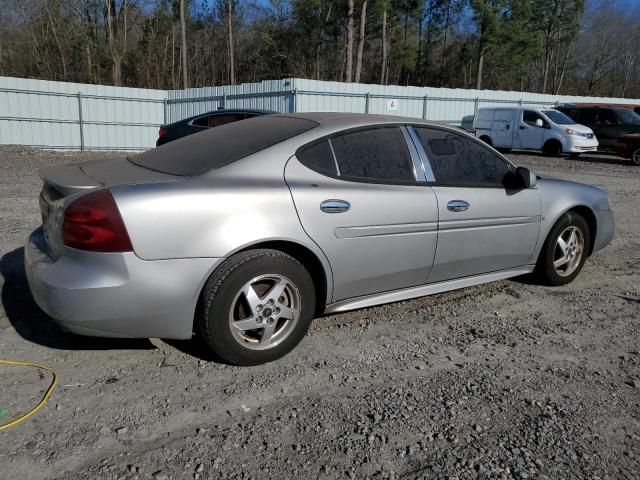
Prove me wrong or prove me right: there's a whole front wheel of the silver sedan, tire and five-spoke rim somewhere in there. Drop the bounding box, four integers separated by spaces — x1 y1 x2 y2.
536 212 591 285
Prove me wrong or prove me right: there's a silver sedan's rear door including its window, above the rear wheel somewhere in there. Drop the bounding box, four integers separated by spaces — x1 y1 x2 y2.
285 125 438 302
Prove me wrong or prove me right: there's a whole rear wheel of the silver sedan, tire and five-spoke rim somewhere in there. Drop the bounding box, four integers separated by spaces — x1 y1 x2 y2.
196 249 315 365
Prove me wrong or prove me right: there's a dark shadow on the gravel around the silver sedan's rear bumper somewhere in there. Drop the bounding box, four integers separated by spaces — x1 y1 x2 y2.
0 248 156 350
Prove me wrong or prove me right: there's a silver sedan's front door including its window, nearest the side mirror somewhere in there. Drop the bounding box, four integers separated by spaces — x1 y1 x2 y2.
414 126 541 283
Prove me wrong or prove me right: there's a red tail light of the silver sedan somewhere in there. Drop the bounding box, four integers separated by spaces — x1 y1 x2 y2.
62 190 133 252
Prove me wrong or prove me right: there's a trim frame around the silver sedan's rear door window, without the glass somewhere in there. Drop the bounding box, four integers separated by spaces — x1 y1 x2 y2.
295 123 427 187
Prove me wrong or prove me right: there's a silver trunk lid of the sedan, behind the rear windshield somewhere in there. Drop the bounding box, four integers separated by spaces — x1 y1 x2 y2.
38 158 184 259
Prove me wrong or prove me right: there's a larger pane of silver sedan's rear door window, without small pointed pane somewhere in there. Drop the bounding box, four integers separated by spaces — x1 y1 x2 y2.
331 127 415 182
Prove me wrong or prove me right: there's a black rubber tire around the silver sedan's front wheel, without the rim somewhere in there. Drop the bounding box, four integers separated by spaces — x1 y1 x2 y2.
536 212 591 286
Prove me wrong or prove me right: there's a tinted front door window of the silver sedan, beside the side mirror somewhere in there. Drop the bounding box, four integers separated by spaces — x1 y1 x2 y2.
414 127 511 187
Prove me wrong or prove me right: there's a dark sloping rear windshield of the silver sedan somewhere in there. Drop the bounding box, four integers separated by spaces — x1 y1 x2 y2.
129 115 318 177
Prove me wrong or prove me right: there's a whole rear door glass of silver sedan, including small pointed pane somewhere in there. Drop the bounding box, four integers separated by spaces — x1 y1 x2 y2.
297 127 416 183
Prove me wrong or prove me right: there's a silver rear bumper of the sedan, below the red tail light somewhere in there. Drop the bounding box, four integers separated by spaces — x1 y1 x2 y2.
25 228 221 339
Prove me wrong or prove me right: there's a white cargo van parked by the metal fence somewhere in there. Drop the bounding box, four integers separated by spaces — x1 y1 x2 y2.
473 107 598 155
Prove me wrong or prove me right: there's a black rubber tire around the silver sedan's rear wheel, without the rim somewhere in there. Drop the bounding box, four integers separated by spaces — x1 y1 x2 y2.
196 249 316 365
